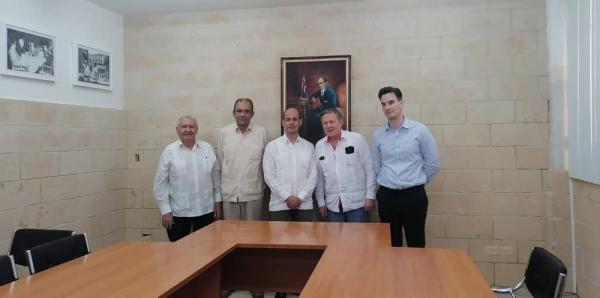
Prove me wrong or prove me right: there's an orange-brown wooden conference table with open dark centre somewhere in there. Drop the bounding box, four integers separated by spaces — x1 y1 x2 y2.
0 221 494 298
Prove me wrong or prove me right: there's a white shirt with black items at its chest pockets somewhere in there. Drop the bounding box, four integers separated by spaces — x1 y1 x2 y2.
315 131 377 212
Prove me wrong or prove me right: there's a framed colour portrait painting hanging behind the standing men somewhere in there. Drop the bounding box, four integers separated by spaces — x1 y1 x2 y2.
281 55 351 144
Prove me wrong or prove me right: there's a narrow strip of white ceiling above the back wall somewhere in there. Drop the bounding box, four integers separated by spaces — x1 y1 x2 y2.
89 0 359 16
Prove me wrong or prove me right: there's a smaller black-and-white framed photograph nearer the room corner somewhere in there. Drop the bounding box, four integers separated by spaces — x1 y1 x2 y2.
73 42 112 90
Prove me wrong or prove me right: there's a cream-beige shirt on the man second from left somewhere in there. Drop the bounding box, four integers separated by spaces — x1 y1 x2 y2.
217 123 268 202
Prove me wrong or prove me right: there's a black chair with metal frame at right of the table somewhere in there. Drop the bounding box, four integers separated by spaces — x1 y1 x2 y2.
492 247 567 298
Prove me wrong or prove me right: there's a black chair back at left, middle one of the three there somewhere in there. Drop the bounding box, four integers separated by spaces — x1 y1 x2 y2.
25 234 90 275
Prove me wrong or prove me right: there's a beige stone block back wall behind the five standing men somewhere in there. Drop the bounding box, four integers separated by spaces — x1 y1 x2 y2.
125 0 550 285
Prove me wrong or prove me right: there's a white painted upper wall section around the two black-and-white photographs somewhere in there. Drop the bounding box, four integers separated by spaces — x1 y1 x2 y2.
0 0 124 109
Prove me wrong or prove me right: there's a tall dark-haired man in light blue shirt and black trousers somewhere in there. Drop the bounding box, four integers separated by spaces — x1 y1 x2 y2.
372 87 440 247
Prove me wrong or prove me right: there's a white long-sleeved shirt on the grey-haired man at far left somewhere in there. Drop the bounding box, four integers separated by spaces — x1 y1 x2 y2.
154 140 222 217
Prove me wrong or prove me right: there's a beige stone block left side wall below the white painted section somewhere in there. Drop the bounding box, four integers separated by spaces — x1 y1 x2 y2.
0 99 127 255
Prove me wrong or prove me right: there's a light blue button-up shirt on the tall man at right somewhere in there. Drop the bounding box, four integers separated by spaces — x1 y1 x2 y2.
372 117 440 189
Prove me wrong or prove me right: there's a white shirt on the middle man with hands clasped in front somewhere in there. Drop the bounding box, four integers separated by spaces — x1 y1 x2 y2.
263 135 317 211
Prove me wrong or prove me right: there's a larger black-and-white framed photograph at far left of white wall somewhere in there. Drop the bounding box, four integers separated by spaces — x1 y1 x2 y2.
2 24 56 81
